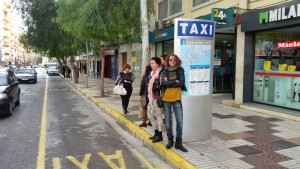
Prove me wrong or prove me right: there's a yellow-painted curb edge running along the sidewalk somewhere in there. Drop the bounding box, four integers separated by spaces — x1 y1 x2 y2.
71 87 196 169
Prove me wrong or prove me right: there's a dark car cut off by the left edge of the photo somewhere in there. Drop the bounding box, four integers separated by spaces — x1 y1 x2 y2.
0 69 21 116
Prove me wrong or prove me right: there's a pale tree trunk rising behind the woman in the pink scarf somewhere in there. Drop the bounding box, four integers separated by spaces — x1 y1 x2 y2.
140 0 149 72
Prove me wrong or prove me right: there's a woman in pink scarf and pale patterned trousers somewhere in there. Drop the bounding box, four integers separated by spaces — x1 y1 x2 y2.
147 57 163 143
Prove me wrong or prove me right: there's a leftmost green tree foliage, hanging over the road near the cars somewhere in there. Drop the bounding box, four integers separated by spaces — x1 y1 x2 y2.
13 0 78 82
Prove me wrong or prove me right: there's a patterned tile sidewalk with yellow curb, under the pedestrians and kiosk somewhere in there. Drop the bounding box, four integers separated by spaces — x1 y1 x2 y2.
66 76 300 169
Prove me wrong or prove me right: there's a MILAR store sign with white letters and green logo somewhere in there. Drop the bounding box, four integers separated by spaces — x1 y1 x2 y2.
259 3 300 24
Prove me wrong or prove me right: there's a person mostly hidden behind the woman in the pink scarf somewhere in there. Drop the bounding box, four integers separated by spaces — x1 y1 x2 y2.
139 65 152 127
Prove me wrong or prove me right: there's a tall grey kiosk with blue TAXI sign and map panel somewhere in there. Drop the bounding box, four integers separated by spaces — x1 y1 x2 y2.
173 18 215 141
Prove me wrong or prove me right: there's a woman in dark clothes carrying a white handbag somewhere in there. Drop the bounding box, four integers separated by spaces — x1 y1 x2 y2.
116 64 135 114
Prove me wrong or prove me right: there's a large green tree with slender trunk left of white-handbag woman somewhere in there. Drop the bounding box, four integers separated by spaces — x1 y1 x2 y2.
57 0 145 96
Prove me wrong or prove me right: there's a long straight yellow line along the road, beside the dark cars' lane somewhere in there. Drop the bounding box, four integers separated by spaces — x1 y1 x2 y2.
36 76 48 169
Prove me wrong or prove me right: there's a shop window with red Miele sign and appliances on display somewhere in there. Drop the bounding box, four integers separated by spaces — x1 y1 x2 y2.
253 28 300 110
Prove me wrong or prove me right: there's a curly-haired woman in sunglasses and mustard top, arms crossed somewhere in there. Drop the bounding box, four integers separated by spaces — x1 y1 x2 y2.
161 54 187 152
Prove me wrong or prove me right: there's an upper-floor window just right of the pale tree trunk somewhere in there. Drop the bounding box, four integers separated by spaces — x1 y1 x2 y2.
158 0 182 20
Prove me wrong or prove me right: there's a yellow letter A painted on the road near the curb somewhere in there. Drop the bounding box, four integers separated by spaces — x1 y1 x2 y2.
98 150 126 169
